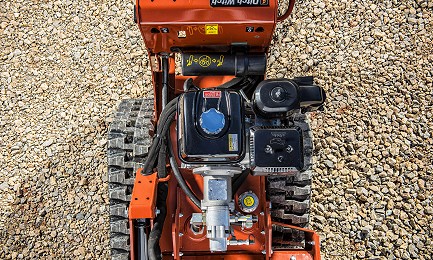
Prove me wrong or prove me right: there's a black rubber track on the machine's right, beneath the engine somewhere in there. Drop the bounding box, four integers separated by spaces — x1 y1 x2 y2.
266 115 313 248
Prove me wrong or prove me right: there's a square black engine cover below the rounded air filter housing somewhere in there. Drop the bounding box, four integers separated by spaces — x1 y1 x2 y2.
250 127 304 175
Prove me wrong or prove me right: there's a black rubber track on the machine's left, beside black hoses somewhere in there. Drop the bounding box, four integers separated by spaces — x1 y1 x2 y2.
107 98 153 260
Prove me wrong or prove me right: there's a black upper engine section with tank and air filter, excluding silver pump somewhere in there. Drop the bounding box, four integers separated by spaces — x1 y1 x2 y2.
177 77 325 171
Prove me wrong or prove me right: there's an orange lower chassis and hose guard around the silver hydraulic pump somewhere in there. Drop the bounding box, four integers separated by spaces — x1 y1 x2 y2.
129 131 320 260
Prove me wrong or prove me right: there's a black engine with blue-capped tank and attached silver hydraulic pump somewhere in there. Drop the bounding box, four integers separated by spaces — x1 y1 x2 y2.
177 77 325 252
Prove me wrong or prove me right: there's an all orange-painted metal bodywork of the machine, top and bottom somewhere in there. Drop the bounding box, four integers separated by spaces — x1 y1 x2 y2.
129 0 320 260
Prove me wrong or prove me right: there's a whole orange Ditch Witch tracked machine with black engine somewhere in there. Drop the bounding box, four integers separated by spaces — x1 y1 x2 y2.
108 0 325 260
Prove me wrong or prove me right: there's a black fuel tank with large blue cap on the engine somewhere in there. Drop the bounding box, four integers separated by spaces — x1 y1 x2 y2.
177 90 245 164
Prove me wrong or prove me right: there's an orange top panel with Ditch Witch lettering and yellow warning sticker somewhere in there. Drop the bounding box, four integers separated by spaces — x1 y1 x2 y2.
135 0 277 53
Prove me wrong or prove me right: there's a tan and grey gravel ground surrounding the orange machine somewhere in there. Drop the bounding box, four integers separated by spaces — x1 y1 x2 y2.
0 0 433 259
